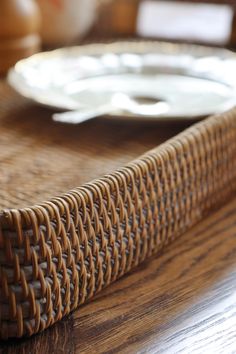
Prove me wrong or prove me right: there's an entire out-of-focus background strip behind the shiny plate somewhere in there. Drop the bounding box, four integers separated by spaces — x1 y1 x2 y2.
0 0 236 72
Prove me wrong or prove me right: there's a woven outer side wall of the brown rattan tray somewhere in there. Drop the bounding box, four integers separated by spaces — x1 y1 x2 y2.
0 88 236 339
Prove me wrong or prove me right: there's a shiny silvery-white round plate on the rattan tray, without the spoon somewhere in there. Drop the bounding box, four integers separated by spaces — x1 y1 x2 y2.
8 42 236 120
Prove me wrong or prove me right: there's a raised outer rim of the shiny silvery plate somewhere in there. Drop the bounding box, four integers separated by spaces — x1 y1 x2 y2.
7 40 236 121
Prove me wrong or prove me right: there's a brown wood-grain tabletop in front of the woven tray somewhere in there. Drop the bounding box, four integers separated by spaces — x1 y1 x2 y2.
0 198 236 354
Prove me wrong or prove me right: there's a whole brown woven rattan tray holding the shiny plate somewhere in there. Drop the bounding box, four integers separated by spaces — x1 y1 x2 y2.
0 81 236 339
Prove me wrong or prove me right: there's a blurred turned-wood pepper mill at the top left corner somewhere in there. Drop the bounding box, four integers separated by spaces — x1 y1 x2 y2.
0 0 40 74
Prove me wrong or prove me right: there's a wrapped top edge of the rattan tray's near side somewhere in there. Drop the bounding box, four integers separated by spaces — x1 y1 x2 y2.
0 108 230 229
